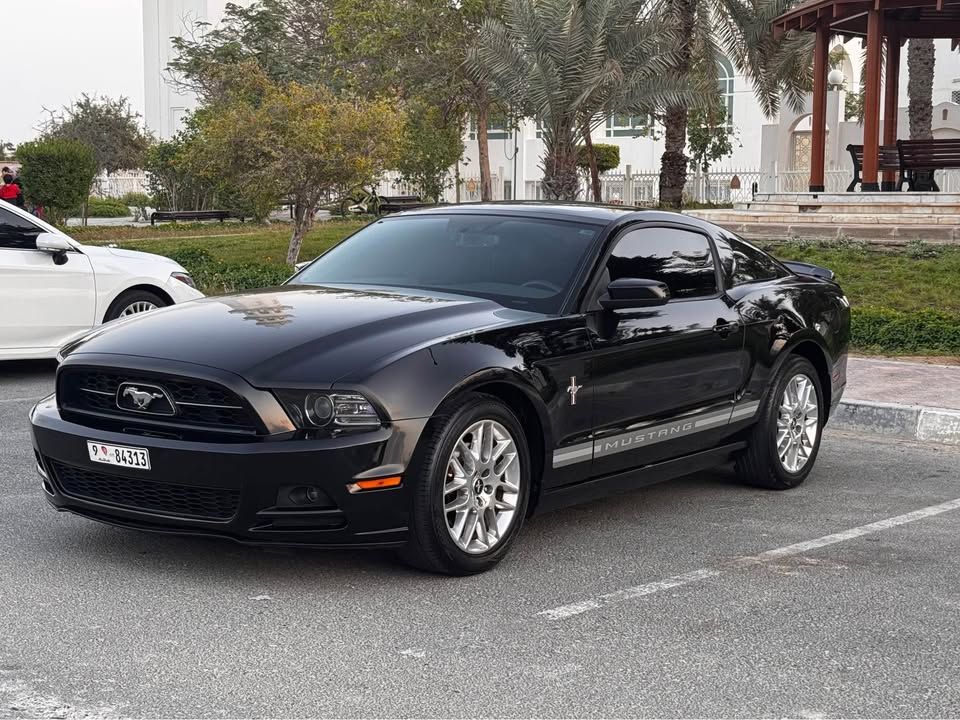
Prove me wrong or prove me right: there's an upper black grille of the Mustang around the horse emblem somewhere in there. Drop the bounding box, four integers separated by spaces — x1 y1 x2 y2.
58 368 260 433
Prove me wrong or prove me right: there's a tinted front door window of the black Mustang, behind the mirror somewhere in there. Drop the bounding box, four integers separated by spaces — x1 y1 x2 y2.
607 228 717 299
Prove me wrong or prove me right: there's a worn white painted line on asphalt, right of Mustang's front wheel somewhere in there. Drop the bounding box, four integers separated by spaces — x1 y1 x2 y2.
537 498 960 620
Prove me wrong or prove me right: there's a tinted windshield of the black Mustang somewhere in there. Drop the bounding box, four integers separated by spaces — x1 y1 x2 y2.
290 215 600 313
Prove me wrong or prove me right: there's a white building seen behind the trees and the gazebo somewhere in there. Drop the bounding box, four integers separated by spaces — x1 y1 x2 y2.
142 0 960 201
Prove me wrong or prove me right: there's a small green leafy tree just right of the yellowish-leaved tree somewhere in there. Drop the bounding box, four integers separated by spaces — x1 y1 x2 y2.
395 102 463 201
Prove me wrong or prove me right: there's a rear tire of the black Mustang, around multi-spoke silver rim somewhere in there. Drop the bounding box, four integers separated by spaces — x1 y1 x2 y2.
736 355 825 490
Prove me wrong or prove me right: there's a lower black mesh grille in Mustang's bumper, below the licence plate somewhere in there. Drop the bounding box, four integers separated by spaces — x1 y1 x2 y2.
49 461 240 520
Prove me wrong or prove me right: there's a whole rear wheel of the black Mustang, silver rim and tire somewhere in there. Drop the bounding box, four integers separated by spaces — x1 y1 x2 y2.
737 356 823 490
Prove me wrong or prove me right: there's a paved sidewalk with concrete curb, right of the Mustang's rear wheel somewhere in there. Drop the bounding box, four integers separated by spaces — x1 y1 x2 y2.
831 358 960 445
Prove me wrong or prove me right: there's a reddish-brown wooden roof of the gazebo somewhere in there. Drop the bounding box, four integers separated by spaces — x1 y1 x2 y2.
772 0 960 39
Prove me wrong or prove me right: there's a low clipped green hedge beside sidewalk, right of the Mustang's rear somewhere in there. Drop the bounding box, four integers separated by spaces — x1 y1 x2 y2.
850 306 960 355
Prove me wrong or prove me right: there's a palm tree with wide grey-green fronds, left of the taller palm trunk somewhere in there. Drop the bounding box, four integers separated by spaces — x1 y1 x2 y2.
473 0 697 200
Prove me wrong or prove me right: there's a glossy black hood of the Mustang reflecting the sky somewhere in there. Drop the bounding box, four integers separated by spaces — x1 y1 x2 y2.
69 285 534 388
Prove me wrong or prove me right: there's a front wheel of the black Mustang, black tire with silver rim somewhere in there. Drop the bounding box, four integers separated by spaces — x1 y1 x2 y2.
401 393 531 575
